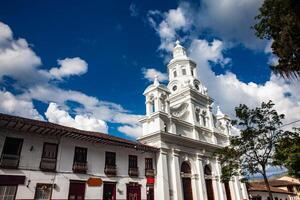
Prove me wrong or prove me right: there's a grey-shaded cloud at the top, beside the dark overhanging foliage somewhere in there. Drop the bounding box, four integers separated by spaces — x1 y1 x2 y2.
197 0 265 49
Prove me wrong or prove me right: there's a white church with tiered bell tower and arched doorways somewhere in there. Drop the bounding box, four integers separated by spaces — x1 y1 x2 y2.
139 41 248 200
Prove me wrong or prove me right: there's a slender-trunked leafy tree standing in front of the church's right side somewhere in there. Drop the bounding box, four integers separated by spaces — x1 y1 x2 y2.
216 101 287 199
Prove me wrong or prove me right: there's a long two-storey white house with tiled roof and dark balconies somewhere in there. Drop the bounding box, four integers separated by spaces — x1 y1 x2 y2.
0 114 157 200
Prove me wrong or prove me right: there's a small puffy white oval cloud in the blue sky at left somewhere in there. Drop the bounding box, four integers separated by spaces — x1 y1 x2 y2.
49 57 88 80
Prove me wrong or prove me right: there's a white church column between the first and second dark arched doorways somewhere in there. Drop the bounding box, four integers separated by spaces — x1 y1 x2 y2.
196 155 207 200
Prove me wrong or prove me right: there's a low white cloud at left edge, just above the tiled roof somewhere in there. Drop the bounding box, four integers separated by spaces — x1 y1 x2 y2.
0 91 43 120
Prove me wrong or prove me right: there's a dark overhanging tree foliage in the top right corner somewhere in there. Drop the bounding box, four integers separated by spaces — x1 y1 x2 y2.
254 0 300 78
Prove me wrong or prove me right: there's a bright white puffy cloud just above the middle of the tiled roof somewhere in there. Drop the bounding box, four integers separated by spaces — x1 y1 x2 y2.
45 102 108 133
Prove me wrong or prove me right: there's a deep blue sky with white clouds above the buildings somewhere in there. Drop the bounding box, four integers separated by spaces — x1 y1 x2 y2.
0 0 300 139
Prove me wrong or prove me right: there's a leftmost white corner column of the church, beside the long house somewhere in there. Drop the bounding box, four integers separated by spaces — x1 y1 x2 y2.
155 149 170 200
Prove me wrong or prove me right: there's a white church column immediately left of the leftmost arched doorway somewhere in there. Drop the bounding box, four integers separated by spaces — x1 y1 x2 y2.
171 149 183 200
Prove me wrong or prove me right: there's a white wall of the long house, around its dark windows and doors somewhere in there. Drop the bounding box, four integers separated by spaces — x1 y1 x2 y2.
0 130 155 199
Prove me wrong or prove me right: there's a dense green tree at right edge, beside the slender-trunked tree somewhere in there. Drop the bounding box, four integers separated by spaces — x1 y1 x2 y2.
274 128 300 178
